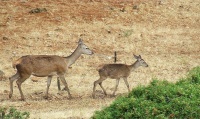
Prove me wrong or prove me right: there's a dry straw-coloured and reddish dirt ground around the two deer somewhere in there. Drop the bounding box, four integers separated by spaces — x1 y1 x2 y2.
0 0 200 119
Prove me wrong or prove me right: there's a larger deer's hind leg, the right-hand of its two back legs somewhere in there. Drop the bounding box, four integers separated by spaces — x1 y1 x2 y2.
16 74 30 101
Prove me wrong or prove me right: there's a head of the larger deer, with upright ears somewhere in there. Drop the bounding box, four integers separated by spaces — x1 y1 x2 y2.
78 39 94 55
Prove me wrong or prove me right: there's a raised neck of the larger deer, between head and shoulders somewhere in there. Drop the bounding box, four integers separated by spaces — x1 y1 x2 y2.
66 46 82 67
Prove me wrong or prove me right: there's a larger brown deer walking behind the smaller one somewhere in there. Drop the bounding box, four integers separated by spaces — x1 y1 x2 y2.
9 39 93 100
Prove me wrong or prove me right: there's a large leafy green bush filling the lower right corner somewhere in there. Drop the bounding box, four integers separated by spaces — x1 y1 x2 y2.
92 67 200 119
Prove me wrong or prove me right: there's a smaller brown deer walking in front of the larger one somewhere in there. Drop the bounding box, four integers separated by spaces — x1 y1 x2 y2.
92 55 148 98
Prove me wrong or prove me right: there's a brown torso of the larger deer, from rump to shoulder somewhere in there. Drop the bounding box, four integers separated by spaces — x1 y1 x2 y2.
14 55 67 77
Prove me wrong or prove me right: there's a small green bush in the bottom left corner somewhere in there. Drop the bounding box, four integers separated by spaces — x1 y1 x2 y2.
0 107 30 119
